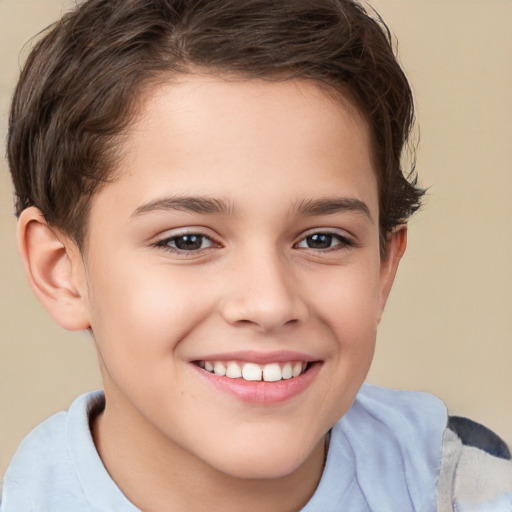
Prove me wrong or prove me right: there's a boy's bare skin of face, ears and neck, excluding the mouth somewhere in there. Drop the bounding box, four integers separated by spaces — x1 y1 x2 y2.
19 75 406 512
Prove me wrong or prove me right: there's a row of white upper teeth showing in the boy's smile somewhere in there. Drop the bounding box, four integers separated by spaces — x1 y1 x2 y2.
194 361 312 382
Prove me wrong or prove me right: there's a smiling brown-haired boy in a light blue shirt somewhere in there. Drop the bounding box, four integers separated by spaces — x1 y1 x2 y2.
2 0 512 512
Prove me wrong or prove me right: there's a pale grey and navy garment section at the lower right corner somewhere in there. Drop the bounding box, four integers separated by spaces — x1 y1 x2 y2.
438 417 512 512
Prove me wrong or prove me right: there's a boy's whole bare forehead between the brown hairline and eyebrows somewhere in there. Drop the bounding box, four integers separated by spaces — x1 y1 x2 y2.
90 75 378 226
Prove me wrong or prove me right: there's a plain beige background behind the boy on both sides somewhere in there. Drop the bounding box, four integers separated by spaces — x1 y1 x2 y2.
0 0 512 480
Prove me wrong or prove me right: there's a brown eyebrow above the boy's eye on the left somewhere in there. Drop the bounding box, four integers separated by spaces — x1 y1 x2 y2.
132 196 235 217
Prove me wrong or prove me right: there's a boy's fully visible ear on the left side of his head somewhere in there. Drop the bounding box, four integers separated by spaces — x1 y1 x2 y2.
18 207 89 331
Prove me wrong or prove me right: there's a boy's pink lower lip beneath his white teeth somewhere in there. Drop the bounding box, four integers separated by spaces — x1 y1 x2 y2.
192 362 322 406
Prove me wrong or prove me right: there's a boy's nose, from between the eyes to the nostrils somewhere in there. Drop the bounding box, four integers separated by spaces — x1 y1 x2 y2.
221 248 308 332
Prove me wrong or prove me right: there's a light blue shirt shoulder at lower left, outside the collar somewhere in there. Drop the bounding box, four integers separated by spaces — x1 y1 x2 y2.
2 394 105 512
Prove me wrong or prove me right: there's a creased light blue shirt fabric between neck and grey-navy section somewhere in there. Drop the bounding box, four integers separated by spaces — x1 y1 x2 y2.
322 384 447 512
